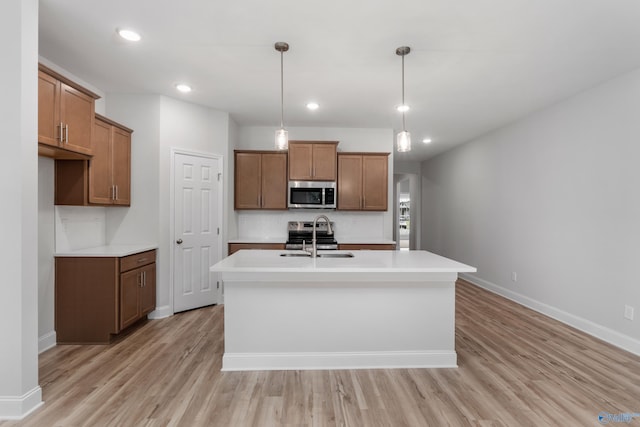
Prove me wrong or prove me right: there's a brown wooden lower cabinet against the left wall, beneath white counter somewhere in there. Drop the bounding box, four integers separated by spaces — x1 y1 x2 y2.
55 250 156 344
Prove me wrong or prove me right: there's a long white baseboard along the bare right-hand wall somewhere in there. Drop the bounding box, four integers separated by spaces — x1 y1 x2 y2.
460 273 640 356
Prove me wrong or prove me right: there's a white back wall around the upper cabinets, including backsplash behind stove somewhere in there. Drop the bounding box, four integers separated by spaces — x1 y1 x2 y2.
232 126 394 242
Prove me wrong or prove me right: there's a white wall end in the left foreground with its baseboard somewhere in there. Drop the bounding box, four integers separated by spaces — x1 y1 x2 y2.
0 0 42 418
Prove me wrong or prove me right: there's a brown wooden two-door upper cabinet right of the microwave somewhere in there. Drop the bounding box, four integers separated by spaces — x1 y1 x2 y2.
338 153 389 211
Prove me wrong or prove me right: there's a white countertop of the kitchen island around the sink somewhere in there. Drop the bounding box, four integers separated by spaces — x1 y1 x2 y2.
211 250 476 273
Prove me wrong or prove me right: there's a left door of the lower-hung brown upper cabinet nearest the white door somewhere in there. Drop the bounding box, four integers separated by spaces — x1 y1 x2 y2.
89 120 113 205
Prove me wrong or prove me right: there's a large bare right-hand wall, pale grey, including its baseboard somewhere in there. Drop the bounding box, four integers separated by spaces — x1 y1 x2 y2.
422 70 640 354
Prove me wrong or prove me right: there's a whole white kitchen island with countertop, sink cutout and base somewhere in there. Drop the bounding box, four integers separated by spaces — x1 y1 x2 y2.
211 250 476 371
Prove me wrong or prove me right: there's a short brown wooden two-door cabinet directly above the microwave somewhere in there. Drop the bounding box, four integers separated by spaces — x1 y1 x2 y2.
289 141 338 181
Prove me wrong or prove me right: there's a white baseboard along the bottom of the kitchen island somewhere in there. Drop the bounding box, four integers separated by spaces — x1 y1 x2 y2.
222 351 458 371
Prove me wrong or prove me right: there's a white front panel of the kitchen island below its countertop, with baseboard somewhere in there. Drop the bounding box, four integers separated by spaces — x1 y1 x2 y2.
223 274 456 370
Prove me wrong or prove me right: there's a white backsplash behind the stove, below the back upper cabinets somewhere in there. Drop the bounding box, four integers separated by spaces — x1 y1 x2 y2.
238 210 390 243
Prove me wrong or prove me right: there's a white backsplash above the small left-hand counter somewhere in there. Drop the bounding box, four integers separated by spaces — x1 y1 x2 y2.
55 206 107 252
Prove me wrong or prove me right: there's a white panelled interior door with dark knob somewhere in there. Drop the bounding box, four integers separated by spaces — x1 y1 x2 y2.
173 153 222 312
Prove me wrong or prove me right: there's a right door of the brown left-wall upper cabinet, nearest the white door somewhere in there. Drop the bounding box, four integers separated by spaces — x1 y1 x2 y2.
111 127 131 206
